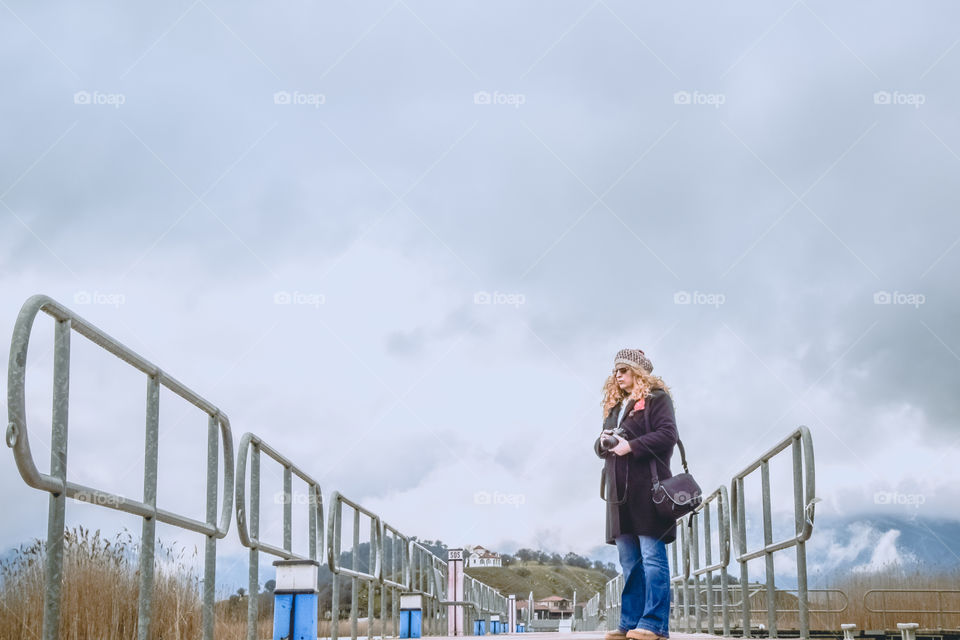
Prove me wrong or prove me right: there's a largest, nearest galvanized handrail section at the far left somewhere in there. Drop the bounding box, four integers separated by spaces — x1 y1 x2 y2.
6 295 234 640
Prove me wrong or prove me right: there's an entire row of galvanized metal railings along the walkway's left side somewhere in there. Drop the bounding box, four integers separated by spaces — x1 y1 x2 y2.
6 295 512 640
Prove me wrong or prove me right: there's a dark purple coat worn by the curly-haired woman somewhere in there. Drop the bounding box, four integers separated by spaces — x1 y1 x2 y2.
593 389 678 545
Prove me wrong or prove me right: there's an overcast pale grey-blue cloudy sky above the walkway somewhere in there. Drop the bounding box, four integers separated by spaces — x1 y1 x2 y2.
0 0 960 596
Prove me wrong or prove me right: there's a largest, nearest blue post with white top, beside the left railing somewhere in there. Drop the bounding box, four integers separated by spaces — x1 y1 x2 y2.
272 560 320 640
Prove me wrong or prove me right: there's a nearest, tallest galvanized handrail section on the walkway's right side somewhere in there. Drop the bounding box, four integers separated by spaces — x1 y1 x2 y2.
730 425 818 639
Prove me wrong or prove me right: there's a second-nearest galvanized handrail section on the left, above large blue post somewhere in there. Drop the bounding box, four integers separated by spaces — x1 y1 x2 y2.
235 431 323 640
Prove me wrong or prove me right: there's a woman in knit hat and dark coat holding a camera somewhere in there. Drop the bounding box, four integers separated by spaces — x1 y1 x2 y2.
593 349 678 640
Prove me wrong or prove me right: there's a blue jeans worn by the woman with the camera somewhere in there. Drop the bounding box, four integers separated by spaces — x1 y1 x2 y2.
614 533 671 638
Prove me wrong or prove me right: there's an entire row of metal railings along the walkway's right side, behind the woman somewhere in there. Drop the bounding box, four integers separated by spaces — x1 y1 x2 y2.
597 425 812 639
